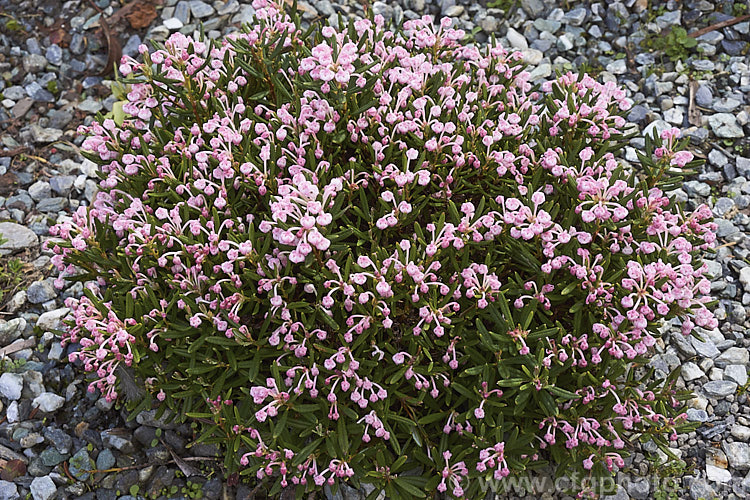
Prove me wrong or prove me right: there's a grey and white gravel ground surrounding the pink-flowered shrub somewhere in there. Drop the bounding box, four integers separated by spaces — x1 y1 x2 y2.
0 0 750 500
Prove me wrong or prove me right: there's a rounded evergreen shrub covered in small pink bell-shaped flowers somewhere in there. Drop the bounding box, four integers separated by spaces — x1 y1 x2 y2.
51 0 716 498
